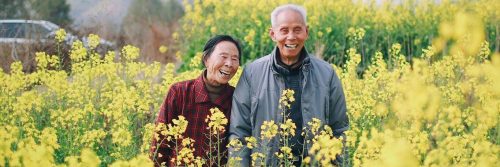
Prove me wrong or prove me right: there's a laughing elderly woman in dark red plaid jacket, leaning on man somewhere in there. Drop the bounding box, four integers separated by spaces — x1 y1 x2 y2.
151 35 241 166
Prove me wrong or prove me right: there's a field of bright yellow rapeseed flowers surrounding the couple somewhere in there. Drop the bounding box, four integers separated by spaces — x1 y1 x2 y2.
0 0 500 167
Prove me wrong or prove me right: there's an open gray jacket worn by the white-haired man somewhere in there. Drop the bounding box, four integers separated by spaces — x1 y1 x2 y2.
229 48 349 166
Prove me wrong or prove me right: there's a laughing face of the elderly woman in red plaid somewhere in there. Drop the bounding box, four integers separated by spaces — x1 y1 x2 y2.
205 41 240 86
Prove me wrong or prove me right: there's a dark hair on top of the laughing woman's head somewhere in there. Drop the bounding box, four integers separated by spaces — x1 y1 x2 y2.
201 35 241 67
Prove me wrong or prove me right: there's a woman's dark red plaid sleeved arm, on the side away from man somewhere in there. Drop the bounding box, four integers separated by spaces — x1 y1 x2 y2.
150 86 178 166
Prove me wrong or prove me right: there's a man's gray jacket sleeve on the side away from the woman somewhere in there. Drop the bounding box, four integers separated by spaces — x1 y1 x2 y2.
328 71 349 166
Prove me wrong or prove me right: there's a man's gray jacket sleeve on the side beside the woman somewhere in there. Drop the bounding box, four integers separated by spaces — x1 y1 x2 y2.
228 69 252 166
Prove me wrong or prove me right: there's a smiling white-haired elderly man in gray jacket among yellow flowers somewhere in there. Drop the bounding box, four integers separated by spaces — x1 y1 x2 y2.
229 4 349 166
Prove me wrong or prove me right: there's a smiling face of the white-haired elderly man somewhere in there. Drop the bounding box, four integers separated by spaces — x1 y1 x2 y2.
269 10 309 64
